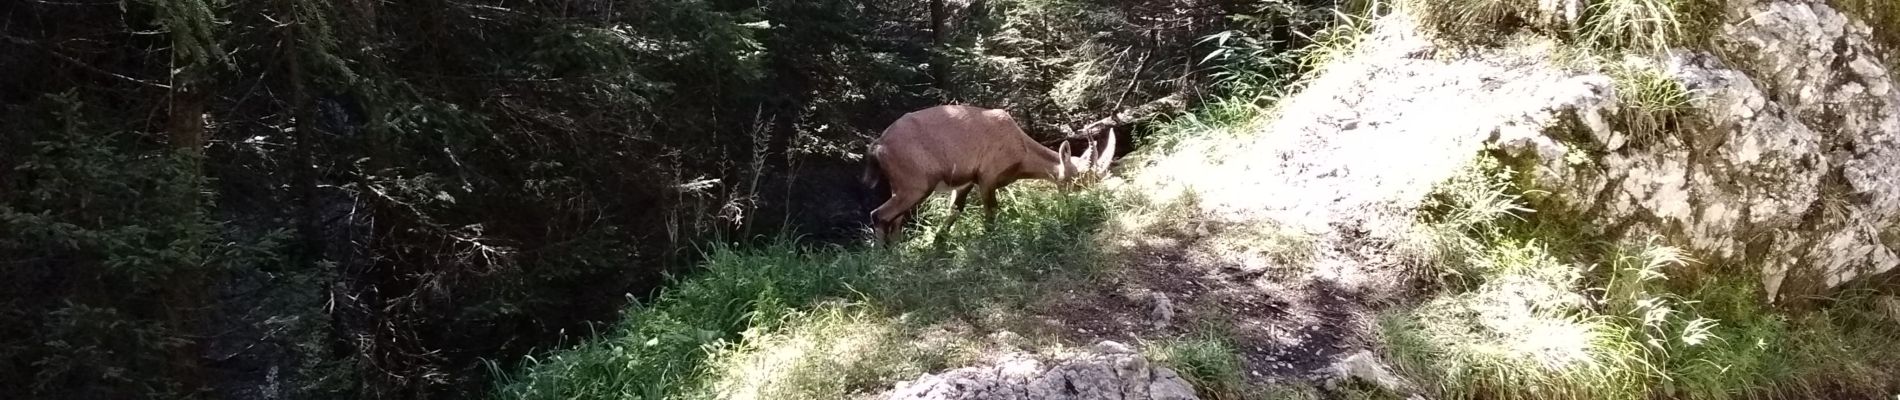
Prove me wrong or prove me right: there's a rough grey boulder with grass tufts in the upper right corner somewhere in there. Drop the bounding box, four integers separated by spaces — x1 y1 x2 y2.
1503 2 1900 300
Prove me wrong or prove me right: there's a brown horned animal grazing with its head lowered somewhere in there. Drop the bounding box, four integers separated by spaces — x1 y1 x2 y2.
865 106 1115 246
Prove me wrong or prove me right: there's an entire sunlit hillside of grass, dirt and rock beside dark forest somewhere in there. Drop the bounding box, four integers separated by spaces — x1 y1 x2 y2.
504 2 1900 400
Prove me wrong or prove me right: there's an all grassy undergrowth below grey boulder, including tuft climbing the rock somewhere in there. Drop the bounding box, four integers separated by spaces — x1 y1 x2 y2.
1379 159 1900 398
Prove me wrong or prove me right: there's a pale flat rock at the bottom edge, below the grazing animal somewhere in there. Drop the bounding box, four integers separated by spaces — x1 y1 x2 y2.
880 341 1197 400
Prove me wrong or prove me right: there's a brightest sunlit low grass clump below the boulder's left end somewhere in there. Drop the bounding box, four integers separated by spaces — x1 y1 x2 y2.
1381 237 1647 398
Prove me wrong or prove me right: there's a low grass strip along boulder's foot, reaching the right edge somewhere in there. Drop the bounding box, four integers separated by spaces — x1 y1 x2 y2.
1381 237 1900 398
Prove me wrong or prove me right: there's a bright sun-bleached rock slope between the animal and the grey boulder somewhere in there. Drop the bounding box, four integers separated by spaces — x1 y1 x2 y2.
1134 15 1613 296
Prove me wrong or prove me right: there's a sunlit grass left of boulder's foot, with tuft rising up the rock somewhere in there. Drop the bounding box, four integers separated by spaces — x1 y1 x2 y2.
1379 159 1651 398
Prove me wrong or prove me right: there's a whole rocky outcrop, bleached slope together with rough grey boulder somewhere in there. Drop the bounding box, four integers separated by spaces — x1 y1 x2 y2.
1138 0 1900 300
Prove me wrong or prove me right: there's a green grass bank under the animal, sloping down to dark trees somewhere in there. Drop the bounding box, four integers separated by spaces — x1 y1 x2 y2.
498 184 1113 400
